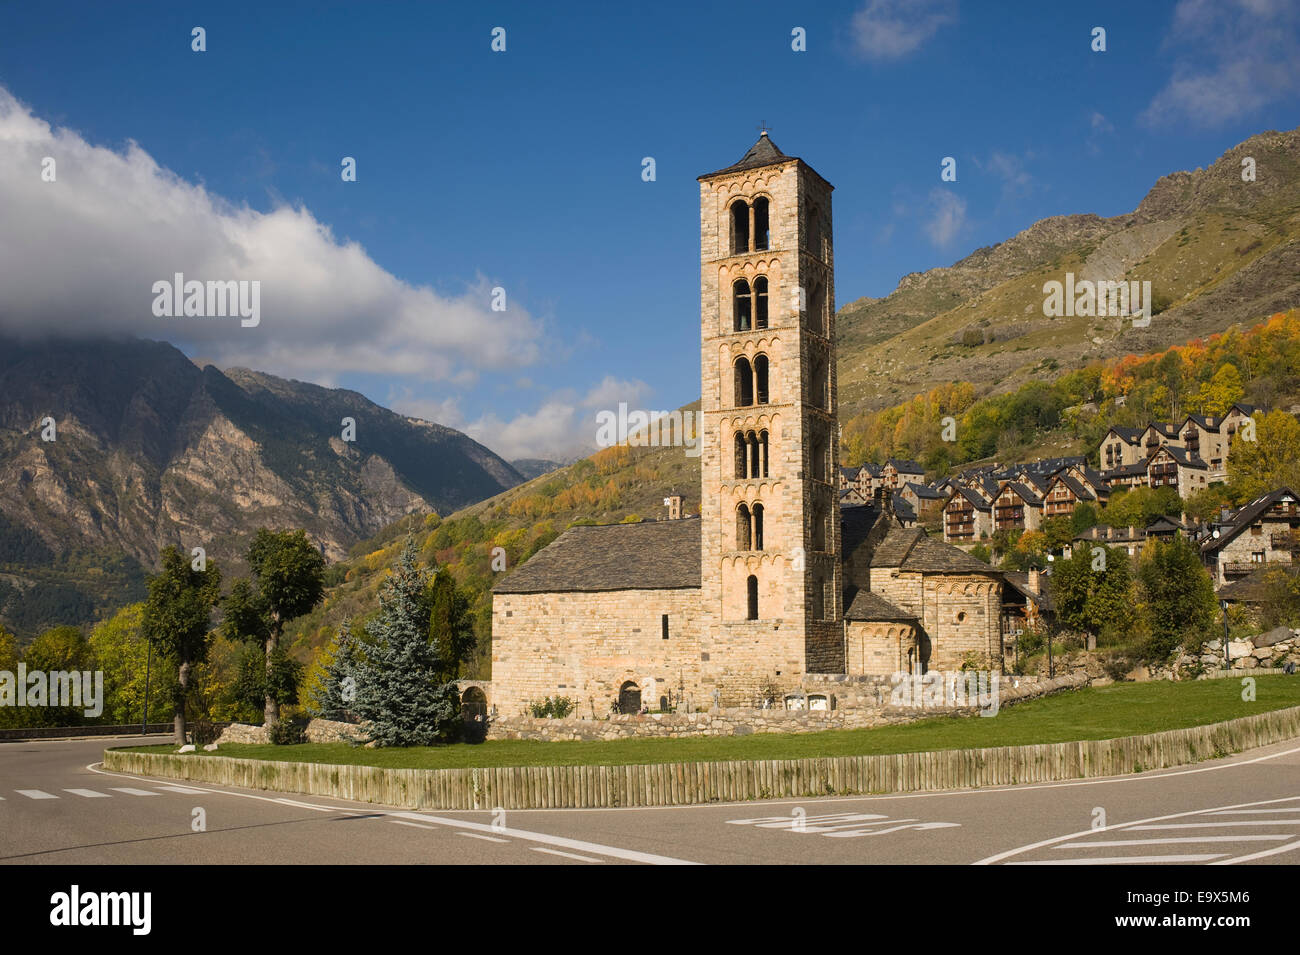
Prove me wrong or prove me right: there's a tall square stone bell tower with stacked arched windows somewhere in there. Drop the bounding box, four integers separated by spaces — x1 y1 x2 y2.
699 131 844 706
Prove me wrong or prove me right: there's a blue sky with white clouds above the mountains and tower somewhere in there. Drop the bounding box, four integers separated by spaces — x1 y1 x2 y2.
0 0 1300 459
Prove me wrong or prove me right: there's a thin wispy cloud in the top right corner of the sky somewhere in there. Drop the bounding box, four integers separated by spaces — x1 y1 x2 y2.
1141 0 1300 126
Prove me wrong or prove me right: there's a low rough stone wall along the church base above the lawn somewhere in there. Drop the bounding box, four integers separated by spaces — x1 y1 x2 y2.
483 673 1088 742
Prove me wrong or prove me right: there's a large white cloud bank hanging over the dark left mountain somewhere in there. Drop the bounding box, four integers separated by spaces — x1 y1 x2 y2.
0 87 541 385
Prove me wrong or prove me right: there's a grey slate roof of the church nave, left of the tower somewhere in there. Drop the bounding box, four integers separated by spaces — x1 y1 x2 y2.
493 517 699 594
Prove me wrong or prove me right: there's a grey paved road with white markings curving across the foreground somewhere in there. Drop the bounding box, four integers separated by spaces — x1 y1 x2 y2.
0 741 1300 865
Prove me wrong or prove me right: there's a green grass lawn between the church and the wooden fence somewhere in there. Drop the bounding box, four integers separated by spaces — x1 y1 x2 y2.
114 674 1300 769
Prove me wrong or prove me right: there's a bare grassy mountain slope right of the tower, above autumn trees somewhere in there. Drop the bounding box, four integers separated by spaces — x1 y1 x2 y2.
837 129 1300 417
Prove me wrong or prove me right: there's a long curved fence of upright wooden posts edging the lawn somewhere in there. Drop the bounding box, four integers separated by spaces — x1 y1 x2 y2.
104 707 1300 809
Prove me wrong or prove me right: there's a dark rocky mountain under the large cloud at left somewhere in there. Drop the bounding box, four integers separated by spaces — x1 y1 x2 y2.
0 339 524 641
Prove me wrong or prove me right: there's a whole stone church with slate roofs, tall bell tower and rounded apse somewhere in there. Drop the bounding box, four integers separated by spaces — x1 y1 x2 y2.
485 133 1002 716
